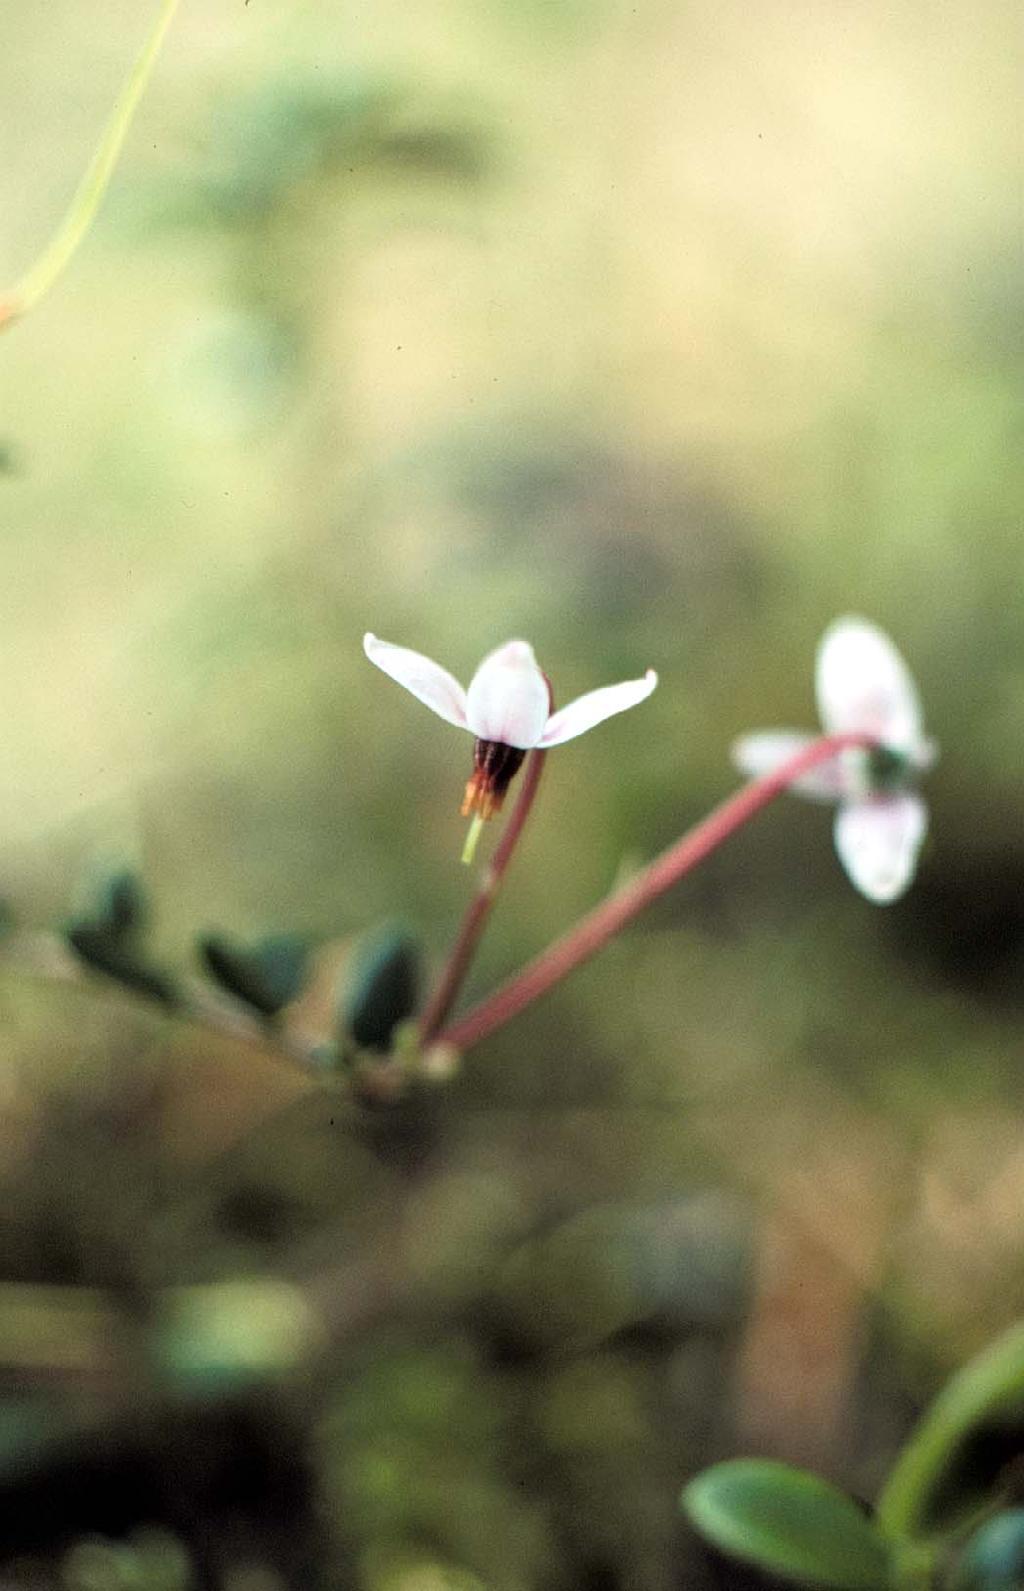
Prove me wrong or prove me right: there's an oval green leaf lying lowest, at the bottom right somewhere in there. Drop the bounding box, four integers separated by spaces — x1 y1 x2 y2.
682 1459 889 1591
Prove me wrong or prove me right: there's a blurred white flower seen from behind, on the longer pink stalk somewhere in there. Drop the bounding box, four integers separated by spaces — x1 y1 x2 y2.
733 617 937 904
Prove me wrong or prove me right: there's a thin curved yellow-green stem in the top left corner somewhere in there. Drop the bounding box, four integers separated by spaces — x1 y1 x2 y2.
0 0 178 329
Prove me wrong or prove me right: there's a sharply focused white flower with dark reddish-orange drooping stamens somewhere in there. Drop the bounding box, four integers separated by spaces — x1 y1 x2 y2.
363 635 658 818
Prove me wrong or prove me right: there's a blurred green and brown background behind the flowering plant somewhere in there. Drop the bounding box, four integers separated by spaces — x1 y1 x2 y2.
0 0 1024 1591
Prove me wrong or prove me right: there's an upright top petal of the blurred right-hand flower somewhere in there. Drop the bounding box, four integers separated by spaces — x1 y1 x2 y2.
816 617 922 754
